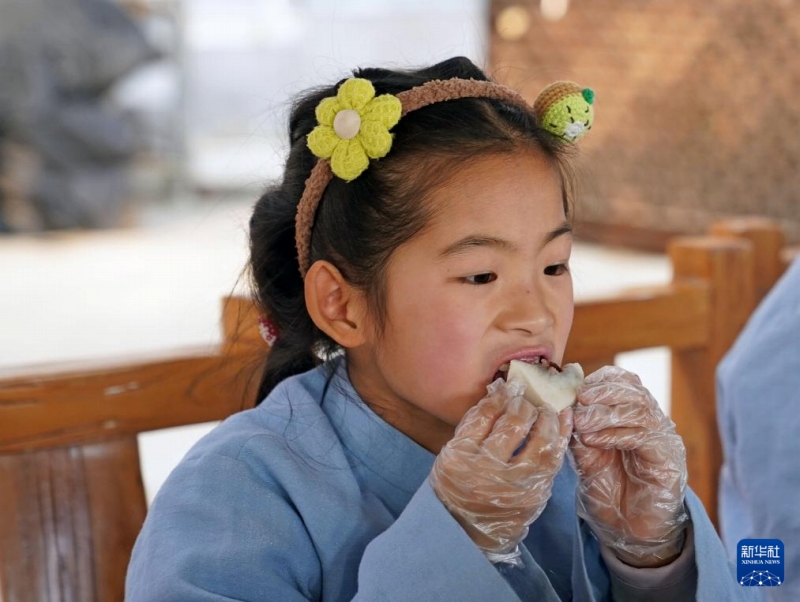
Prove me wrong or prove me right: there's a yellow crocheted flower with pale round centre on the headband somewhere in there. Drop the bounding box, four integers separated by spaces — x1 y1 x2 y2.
308 78 402 182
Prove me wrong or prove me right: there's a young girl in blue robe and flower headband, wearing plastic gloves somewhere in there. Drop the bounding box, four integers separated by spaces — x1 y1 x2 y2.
127 58 744 602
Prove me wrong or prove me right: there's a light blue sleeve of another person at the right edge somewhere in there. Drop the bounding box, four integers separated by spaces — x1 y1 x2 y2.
717 260 800 602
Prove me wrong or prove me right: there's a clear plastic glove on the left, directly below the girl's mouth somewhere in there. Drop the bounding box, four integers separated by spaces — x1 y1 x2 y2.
430 380 572 564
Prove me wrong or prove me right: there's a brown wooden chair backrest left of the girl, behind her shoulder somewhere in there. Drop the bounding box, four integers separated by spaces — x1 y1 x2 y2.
0 298 267 602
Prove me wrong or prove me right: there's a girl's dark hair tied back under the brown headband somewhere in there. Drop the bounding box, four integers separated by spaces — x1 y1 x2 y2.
249 57 571 402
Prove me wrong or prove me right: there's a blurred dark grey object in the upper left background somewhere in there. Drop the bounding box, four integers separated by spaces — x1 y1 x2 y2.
0 0 159 231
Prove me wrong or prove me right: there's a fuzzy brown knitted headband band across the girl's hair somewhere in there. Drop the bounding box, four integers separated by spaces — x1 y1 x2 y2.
295 79 531 277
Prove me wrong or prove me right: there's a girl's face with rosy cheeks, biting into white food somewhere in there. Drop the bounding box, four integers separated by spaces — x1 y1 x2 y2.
348 152 573 453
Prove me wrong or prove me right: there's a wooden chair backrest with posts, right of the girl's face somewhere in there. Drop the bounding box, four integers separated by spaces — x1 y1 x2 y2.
567 218 796 524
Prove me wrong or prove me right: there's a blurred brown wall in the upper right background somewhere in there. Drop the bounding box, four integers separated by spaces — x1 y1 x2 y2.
490 0 800 250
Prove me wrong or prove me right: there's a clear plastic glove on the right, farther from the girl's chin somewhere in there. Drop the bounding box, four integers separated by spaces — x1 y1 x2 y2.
570 366 689 567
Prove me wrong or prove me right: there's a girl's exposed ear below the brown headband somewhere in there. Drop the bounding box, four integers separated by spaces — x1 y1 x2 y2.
305 260 367 349
